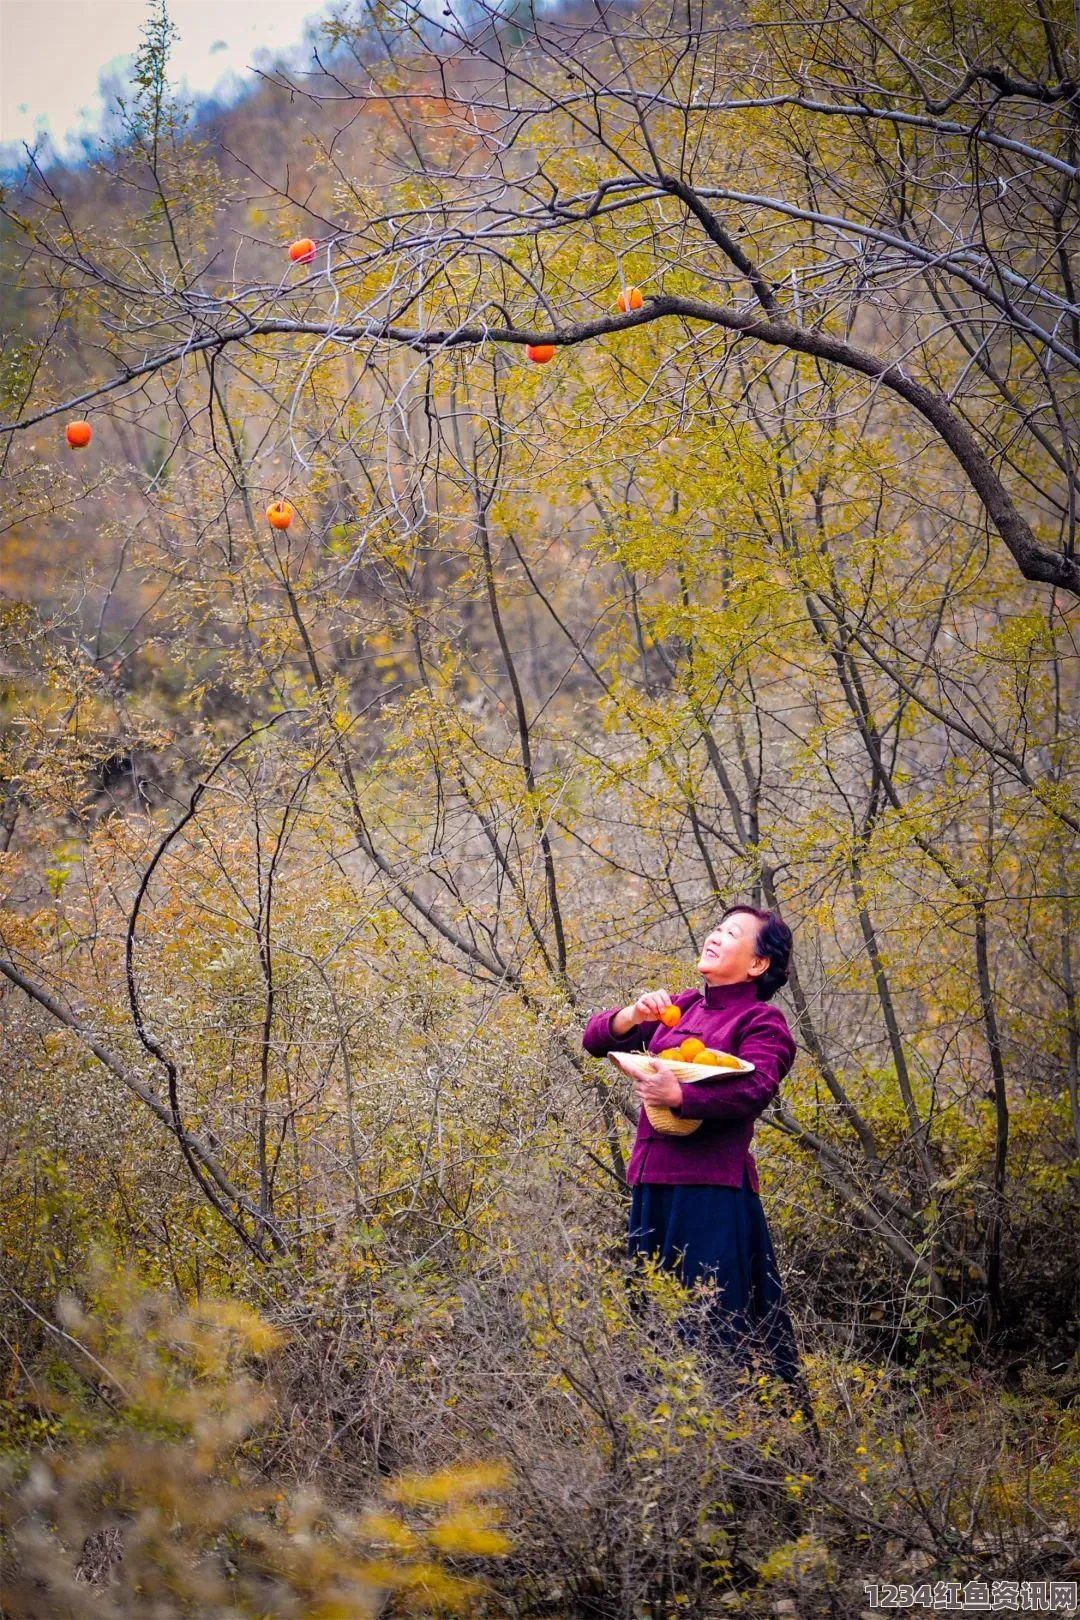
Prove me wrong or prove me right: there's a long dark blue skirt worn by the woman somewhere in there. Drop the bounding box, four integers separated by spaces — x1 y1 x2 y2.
628 1173 801 1385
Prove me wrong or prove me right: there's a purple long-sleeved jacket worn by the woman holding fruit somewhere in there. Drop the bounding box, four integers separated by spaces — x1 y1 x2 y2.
581 980 795 1192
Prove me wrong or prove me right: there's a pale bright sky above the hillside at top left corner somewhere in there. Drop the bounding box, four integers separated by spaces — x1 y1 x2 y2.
0 0 329 162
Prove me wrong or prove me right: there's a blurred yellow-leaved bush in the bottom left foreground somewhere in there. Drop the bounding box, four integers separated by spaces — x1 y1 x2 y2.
0 1262 508 1620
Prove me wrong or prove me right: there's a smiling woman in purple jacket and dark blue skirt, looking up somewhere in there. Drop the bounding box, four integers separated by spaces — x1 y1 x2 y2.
581 906 810 1418
